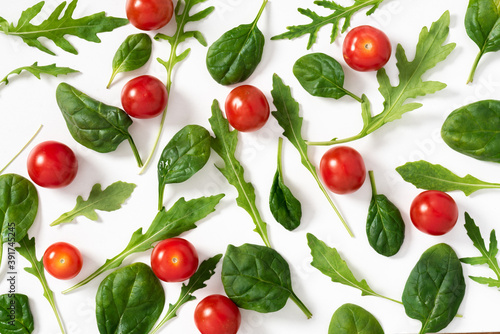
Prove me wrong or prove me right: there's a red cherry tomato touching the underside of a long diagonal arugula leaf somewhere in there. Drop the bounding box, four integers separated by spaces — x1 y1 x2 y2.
151 238 198 282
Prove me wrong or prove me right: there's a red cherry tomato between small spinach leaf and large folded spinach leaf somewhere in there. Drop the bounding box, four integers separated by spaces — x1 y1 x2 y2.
121 75 168 118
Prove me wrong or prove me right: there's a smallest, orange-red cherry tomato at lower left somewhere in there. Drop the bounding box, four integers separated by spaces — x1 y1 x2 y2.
43 242 83 279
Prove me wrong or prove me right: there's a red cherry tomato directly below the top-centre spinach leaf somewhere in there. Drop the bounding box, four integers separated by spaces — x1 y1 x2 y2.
225 85 270 132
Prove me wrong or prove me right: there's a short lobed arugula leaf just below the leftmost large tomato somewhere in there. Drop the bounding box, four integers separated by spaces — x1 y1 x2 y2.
50 181 136 226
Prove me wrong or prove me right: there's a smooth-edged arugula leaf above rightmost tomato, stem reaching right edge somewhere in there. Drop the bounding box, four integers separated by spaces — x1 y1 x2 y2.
396 160 500 196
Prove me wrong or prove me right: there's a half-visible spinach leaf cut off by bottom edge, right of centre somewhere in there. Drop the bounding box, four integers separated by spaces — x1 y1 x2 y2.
328 304 384 334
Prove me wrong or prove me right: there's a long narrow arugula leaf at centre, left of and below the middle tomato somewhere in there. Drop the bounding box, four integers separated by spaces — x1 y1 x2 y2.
209 100 271 247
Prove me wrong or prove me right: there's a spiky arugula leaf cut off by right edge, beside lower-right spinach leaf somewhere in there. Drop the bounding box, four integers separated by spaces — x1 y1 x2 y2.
460 212 500 289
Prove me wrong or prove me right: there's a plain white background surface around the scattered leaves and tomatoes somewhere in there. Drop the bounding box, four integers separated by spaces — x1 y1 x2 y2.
0 0 500 334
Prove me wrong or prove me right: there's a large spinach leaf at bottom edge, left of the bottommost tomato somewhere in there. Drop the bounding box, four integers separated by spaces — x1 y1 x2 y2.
96 262 165 334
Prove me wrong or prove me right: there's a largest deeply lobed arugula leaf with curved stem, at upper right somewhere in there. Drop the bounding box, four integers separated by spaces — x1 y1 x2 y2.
308 11 456 145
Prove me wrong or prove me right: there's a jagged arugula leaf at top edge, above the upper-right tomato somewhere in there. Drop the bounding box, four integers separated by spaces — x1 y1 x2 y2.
271 0 384 50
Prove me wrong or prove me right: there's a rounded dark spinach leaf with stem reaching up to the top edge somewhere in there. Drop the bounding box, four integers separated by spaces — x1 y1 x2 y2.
207 0 268 85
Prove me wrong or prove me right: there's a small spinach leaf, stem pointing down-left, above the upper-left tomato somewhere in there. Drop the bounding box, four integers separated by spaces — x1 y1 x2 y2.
106 33 153 88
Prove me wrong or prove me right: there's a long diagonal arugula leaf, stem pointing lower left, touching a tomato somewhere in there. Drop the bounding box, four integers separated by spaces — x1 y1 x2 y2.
63 194 224 293
